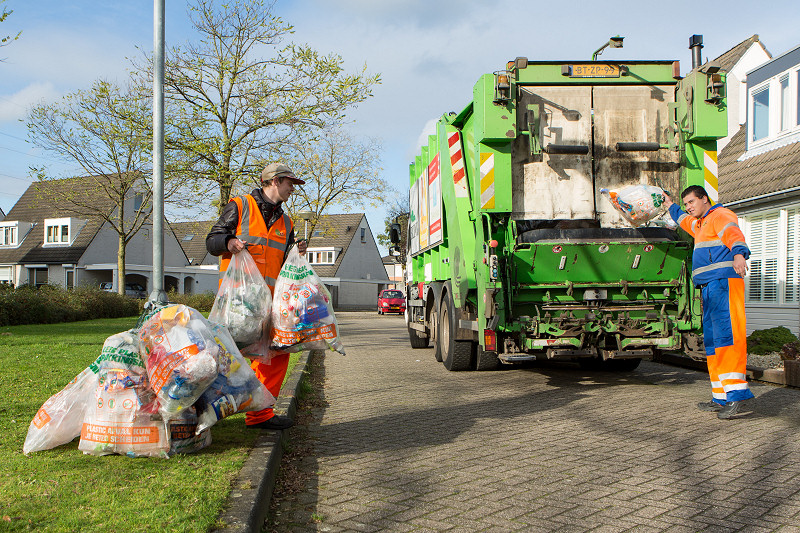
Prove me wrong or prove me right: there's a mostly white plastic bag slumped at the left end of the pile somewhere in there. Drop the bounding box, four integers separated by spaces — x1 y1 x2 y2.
23 331 145 454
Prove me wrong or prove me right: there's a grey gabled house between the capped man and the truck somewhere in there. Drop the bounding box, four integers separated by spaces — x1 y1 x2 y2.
304 213 389 309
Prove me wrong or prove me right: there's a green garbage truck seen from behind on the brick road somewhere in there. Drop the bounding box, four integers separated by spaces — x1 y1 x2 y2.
390 35 727 371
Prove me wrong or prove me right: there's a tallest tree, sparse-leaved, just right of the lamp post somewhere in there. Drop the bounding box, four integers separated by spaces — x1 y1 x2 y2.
135 0 380 210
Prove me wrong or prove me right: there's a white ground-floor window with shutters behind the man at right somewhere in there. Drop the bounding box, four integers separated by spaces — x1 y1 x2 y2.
740 206 800 307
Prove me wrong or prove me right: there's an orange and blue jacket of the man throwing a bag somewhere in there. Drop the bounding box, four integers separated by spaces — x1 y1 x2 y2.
669 204 750 285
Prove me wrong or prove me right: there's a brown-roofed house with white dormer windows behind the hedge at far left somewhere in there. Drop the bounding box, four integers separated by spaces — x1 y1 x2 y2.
0 177 217 293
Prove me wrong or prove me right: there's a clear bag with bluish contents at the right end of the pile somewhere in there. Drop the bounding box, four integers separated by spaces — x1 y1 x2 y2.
194 324 275 433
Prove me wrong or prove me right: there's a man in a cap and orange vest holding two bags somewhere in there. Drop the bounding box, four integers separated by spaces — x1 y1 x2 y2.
206 163 307 429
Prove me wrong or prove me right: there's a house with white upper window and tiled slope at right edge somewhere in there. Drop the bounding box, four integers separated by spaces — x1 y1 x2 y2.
719 41 800 334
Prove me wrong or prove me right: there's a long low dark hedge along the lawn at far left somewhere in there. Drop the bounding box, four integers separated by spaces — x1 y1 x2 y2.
0 285 139 326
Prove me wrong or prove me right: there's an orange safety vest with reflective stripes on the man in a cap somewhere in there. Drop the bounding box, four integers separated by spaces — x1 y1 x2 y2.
219 194 293 290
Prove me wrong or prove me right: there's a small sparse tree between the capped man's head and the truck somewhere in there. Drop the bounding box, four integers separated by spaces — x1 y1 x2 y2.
282 128 393 231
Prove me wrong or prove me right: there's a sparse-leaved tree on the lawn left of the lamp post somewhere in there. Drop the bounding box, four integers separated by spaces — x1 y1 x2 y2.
26 80 162 294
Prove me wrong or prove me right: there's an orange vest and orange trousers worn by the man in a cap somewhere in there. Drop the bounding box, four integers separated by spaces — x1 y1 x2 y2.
219 194 294 426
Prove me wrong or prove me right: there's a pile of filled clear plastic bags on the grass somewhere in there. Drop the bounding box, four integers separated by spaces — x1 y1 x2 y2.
23 305 275 457
